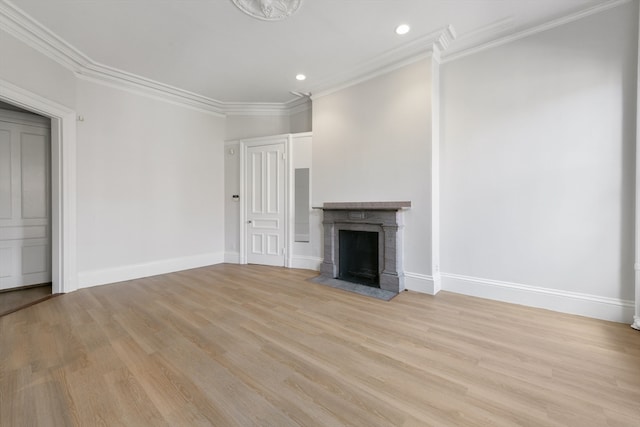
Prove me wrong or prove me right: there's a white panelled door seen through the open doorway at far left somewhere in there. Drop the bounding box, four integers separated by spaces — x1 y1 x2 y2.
0 111 51 290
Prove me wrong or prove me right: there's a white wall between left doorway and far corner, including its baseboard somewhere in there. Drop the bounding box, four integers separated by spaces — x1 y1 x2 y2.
77 80 225 286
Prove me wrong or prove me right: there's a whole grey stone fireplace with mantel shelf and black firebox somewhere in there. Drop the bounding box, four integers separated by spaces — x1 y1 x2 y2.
320 202 411 293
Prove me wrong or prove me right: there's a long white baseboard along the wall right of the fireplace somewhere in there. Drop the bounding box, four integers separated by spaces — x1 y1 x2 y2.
442 273 634 323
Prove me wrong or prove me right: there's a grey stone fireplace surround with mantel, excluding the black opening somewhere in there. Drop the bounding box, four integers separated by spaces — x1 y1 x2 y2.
318 201 411 293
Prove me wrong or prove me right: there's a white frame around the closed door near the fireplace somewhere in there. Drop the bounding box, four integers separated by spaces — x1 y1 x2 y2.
239 134 293 268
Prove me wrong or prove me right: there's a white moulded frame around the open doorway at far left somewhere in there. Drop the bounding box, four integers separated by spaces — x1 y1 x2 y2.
0 79 78 294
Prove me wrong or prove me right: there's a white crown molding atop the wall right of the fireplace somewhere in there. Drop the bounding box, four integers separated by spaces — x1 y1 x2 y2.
442 0 631 63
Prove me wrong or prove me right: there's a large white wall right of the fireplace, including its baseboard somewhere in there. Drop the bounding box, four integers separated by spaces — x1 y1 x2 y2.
441 2 638 320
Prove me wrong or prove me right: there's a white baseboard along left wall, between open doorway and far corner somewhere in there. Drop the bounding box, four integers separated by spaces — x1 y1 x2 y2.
78 252 225 289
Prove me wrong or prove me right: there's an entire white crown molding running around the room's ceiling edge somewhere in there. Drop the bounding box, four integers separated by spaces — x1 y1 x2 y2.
0 0 632 112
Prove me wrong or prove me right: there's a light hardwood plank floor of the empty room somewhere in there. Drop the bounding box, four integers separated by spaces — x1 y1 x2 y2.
0 264 640 427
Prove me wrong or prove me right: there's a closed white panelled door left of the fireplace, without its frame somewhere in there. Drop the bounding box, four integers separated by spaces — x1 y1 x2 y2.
245 143 286 266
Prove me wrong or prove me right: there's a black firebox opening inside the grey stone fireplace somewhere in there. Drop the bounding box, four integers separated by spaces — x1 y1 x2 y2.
338 230 380 288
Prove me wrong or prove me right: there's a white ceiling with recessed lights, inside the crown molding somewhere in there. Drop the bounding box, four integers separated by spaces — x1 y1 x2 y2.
6 0 612 103
